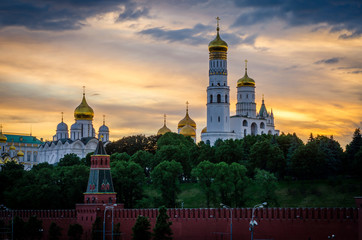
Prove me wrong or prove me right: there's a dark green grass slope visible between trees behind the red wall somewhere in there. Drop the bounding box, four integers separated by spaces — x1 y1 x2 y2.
140 177 362 208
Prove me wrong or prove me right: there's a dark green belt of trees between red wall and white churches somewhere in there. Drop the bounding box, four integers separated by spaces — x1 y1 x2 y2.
0 129 362 209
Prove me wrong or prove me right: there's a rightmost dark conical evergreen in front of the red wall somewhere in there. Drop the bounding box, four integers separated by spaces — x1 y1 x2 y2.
153 207 173 240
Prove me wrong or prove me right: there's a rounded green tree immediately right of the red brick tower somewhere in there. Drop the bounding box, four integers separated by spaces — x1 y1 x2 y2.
111 161 146 208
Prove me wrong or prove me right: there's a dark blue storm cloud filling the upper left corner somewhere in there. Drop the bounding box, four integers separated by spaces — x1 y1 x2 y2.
0 0 147 31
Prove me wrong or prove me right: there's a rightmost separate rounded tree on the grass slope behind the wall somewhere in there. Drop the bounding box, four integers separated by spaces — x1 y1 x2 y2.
254 169 278 206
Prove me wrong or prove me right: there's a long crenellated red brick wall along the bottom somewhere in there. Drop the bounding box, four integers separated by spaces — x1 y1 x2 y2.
0 204 361 240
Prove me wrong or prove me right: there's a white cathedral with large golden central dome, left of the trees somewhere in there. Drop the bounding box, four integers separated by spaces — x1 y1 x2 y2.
38 91 109 164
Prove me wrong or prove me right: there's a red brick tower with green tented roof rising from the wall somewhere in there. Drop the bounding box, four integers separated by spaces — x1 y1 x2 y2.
84 141 116 204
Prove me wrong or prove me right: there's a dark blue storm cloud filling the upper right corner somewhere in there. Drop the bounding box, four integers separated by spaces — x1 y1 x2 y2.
234 0 362 39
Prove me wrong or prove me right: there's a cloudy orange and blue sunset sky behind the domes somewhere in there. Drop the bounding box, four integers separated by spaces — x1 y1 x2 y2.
0 0 362 147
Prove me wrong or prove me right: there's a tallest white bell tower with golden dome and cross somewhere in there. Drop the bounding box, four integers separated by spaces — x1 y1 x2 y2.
201 17 234 145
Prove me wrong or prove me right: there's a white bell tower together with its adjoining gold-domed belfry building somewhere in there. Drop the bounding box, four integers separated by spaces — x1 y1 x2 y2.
201 19 279 145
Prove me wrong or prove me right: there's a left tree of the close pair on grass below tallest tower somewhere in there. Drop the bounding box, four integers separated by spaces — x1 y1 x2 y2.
192 161 216 208
